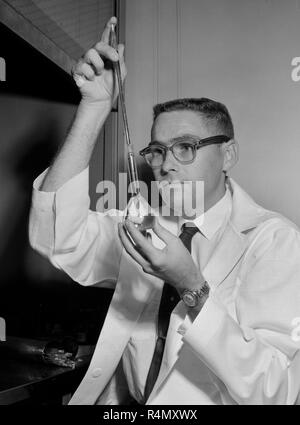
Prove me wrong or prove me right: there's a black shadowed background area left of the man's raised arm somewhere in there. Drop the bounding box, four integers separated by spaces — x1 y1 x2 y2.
0 25 112 343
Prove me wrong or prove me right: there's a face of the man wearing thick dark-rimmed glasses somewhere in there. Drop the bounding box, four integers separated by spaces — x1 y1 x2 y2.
151 110 224 209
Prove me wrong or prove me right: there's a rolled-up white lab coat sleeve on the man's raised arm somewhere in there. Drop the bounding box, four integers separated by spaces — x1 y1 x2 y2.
29 168 122 288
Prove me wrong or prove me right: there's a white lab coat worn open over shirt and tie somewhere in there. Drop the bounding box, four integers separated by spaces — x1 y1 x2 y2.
30 170 300 405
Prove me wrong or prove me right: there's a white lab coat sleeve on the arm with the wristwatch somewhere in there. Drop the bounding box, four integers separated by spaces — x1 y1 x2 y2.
183 225 300 404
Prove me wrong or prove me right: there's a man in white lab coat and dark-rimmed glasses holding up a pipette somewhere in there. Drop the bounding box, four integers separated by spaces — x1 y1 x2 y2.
30 18 300 404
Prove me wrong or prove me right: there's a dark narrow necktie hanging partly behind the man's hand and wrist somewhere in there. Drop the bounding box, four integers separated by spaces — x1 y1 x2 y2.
144 224 199 402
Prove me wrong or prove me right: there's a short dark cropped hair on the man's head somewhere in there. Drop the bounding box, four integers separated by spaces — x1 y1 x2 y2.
153 97 234 139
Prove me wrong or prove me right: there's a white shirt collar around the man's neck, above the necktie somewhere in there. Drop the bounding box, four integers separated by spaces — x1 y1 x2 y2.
178 186 232 239
